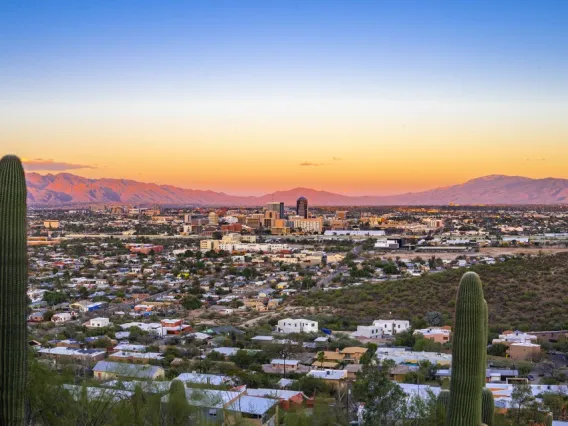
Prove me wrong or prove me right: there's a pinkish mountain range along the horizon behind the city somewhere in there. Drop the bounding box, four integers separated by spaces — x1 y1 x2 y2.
26 173 568 206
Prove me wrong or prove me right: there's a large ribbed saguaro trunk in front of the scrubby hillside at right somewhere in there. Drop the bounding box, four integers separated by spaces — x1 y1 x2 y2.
446 272 487 426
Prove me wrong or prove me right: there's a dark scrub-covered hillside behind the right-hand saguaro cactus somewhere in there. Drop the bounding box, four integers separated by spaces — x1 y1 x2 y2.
290 253 568 331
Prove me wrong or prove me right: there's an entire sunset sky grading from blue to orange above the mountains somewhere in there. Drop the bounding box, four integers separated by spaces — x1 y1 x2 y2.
0 0 568 194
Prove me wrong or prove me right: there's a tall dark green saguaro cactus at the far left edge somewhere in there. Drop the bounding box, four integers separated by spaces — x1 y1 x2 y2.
0 156 28 425
